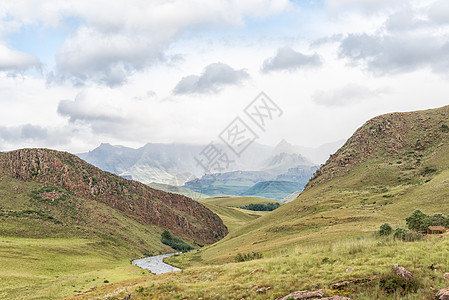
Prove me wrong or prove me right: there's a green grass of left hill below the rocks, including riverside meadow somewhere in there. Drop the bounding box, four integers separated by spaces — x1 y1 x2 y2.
0 176 168 299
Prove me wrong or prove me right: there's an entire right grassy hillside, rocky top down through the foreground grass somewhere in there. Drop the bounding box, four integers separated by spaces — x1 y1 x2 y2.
67 106 449 299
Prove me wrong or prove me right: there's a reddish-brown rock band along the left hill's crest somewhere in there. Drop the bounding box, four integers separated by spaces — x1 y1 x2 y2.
0 149 228 244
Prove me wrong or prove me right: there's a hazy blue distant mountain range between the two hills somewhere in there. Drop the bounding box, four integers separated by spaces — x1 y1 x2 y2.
78 140 340 200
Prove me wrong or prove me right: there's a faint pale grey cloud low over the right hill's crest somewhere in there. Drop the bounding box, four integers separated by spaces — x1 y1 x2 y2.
312 83 386 107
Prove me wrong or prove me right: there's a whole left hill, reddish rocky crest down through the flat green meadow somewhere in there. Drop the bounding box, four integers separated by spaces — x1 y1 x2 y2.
0 149 227 299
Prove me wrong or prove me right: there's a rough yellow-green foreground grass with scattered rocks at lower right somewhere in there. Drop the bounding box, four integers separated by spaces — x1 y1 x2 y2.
68 236 449 300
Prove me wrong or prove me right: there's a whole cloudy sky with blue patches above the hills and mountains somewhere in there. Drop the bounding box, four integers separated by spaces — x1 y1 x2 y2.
0 0 449 152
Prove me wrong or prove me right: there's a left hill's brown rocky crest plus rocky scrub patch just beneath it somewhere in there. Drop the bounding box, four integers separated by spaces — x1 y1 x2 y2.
0 149 227 247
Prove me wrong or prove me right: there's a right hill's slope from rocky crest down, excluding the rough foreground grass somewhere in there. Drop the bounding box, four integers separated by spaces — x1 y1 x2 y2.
179 106 449 262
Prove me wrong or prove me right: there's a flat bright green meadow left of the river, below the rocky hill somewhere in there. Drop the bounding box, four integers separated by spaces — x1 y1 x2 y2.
0 237 148 299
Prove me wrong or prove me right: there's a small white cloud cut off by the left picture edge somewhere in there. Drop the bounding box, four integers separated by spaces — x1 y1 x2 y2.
0 44 40 71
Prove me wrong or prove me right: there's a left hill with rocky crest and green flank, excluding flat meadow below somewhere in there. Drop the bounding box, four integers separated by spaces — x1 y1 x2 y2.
0 149 227 253
